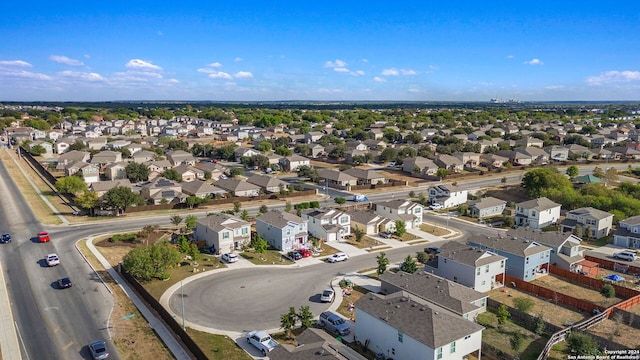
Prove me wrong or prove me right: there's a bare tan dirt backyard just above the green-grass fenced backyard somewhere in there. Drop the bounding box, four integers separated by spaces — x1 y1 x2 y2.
489 288 587 327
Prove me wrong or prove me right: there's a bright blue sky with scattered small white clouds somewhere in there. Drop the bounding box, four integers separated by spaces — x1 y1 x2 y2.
0 0 640 101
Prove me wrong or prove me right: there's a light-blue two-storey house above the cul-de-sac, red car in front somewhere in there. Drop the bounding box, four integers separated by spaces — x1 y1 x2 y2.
256 210 309 251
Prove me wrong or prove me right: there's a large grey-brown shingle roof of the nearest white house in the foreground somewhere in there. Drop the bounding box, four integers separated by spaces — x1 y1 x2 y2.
355 292 484 349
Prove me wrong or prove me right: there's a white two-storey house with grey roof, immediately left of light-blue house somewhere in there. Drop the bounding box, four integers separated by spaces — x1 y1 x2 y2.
425 241 507 292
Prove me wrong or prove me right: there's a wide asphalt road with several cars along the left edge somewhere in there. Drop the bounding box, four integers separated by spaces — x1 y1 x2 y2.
0 150 118 359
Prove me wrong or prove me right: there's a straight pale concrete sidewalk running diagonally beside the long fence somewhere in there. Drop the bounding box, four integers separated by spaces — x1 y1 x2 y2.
86 237 191 360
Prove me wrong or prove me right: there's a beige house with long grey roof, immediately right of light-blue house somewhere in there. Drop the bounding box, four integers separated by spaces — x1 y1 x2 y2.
507 228 584 272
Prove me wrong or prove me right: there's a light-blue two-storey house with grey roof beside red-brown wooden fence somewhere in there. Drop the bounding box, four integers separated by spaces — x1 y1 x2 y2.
468 233 551 281
